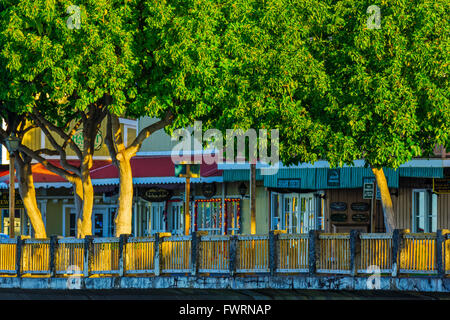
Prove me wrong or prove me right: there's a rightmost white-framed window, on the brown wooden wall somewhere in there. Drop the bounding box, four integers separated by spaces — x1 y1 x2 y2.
412 190 438 232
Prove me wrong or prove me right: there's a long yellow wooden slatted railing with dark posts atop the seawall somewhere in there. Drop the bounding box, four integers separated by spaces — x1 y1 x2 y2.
0 233 450 276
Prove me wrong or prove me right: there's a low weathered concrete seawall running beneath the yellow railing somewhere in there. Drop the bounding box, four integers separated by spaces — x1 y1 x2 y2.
0 276 450 292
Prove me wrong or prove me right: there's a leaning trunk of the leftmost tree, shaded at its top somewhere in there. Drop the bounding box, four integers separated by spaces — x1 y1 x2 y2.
16 162 47 239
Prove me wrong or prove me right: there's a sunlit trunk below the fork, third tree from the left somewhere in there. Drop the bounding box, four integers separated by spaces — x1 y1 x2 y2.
114 153 133 237
